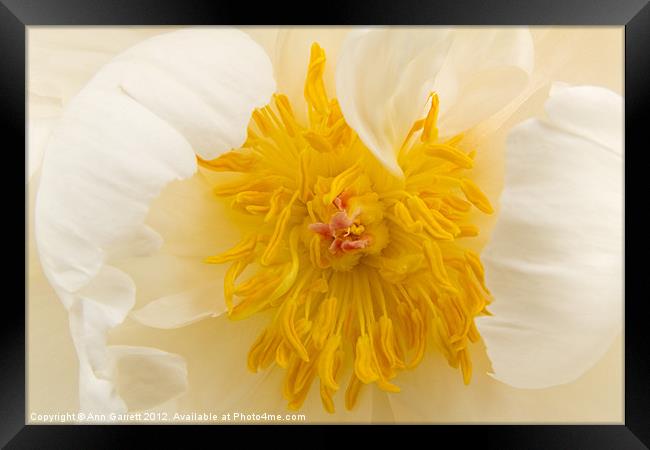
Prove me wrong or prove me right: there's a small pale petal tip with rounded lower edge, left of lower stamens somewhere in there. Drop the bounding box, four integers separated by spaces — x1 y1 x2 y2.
131 280 226 328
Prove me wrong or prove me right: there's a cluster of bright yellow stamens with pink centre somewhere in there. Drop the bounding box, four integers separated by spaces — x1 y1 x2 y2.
199 44 493 412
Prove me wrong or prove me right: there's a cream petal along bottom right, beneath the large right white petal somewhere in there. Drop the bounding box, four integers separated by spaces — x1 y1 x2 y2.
387 338 623 424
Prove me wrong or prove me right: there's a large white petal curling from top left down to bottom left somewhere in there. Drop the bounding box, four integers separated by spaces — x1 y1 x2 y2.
35 29 274 411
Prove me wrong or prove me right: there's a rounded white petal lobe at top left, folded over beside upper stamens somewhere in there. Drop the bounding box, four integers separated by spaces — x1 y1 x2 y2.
111 29 275 159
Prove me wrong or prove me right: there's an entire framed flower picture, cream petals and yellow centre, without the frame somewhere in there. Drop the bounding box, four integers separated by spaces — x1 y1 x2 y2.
28 27 623 423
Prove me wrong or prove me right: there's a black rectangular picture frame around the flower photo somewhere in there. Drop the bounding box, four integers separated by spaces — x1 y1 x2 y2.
6 0 650 449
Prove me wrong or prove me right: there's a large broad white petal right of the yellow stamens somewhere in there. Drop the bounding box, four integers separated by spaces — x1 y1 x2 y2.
477 88 623 388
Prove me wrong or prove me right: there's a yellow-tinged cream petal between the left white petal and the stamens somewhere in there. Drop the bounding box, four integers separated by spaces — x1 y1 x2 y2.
118 171 246 328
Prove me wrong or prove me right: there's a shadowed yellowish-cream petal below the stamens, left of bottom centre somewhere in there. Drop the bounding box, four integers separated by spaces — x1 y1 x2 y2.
105 311 375 423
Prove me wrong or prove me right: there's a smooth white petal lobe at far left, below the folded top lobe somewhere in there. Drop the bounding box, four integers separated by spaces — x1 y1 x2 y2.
36 90 196 292
